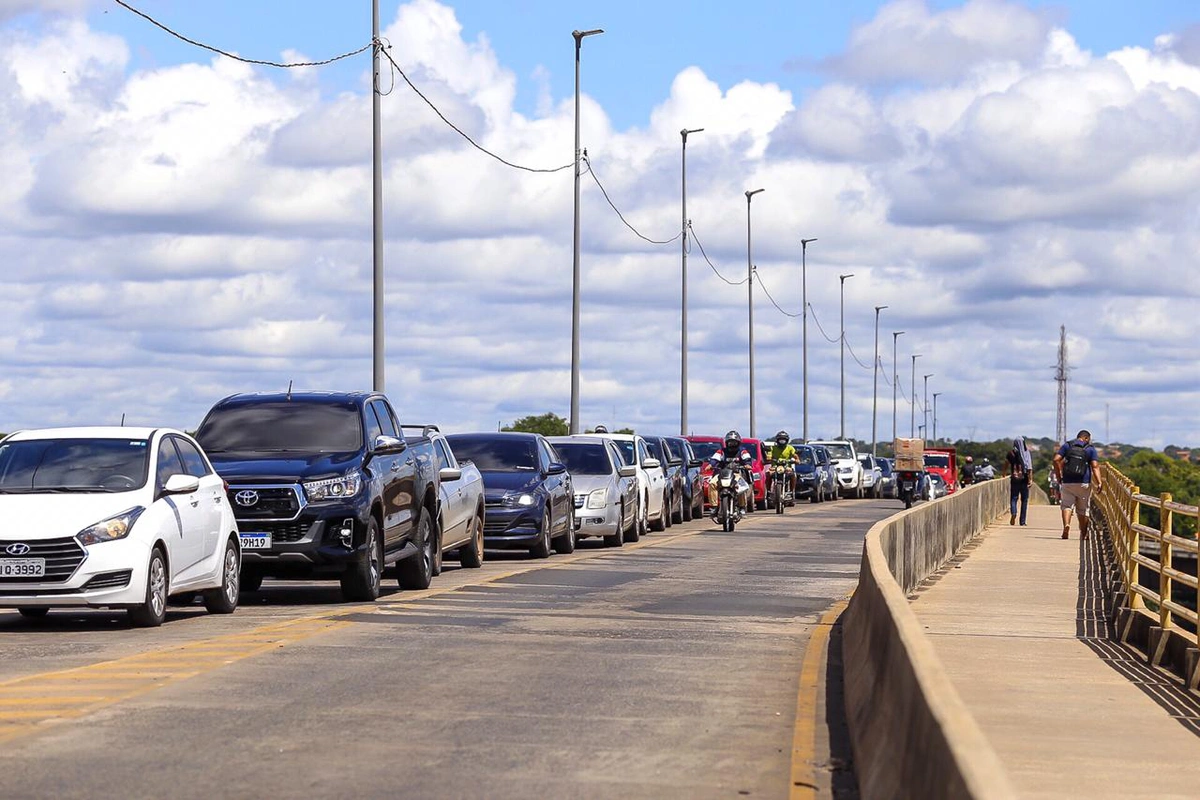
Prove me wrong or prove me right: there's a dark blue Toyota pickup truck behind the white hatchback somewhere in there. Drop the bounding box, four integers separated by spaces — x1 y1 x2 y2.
196 391 439 601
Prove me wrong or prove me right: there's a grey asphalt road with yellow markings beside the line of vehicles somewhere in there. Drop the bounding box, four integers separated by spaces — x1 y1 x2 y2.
0 500 899 799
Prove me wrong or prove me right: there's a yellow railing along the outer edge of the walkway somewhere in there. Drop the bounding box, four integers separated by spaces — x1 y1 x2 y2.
1092 464 1200 646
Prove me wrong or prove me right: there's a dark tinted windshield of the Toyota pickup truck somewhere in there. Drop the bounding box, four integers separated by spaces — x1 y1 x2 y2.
196 402 362 453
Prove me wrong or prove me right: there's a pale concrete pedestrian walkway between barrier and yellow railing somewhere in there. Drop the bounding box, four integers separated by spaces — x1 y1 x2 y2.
912 505 1200 798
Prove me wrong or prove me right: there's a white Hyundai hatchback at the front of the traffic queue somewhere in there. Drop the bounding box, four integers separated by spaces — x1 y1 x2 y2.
0 427 241 627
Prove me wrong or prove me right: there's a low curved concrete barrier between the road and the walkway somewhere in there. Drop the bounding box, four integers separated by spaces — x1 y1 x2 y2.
842 480 1022 800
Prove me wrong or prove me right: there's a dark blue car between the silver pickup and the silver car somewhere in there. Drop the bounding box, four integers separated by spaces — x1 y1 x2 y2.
446 433 575 558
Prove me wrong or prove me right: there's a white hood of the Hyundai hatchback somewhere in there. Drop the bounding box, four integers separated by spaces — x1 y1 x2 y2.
0 492 146 542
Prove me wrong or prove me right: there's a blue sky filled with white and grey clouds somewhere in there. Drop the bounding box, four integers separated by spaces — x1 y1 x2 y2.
0 0 1200 446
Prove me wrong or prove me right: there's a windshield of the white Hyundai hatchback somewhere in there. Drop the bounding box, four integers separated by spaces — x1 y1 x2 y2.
0 439 150 493
